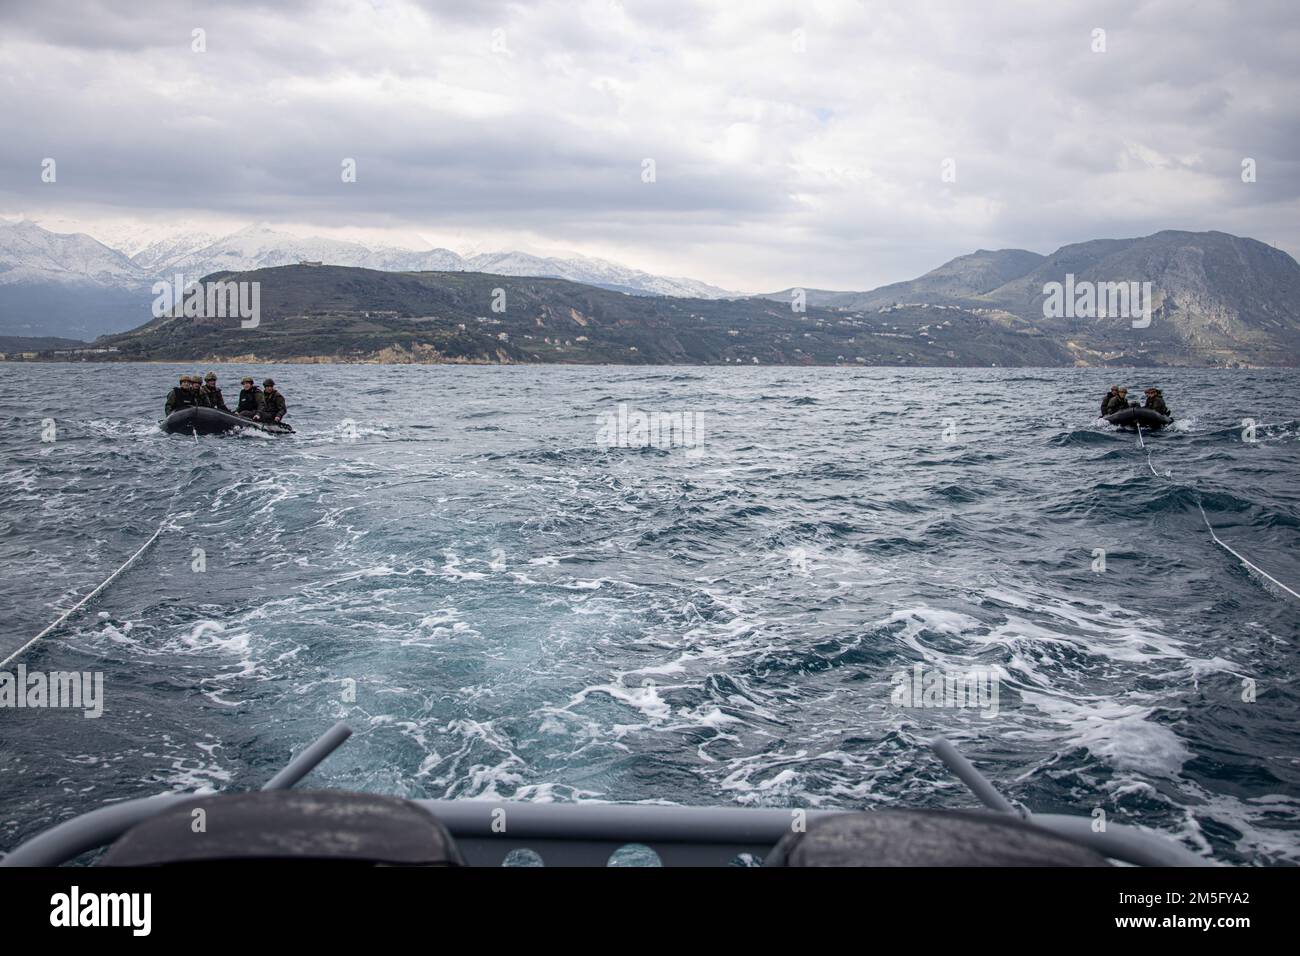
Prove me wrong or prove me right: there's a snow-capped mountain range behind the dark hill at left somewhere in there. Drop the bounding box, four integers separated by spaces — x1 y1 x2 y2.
0 220 732 338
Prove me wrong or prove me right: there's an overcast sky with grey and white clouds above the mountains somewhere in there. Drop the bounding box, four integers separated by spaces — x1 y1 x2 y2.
0 0 1300 291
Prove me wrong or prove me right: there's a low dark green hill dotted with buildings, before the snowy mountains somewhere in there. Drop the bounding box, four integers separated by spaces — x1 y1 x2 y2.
95 265 1070 365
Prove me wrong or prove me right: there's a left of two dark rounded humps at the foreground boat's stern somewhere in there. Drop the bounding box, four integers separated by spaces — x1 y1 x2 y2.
103 790 465 866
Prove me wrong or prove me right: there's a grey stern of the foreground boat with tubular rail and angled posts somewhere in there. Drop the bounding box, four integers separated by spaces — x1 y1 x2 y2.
0 724 1213 868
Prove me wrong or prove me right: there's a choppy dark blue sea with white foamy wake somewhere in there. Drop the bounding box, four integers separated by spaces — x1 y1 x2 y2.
0 365 1300 864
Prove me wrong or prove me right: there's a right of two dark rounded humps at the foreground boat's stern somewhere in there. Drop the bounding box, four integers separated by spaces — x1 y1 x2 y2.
763 810 1110 866
